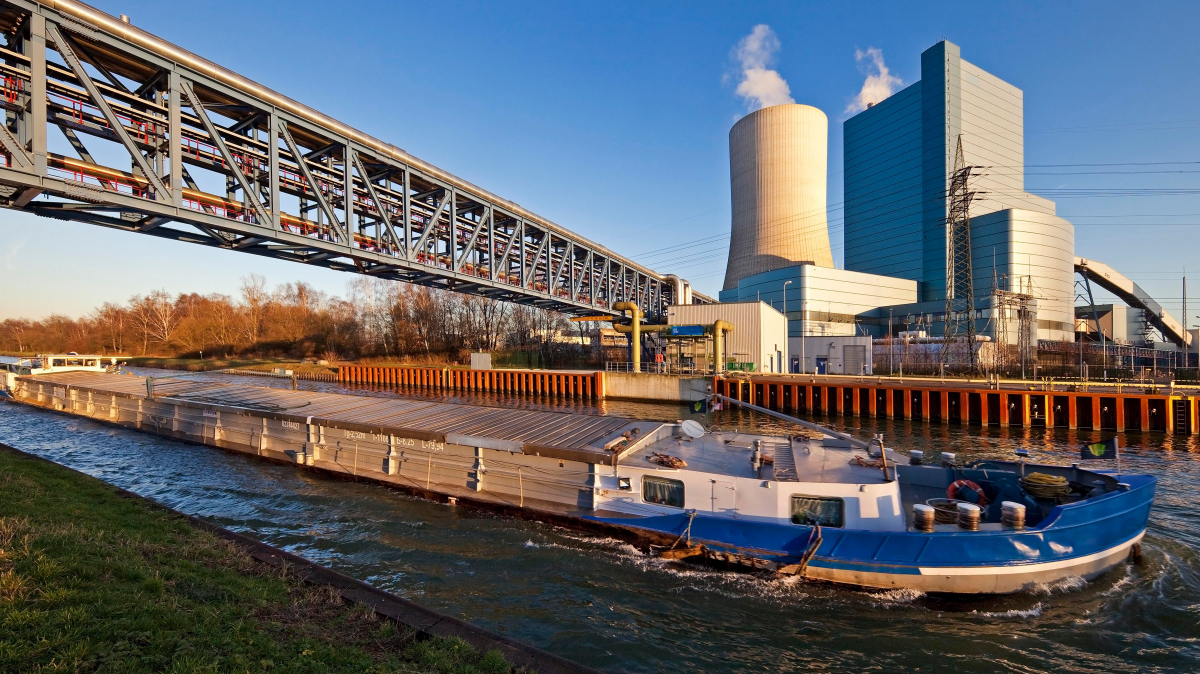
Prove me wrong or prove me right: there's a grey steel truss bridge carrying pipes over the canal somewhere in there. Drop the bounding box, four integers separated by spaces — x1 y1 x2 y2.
0 0 712 319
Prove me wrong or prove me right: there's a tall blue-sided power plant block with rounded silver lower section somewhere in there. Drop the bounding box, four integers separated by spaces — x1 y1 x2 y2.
844 41 1075 339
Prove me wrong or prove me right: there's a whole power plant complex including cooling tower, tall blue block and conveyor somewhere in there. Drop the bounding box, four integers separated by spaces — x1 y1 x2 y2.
705 41 1186 372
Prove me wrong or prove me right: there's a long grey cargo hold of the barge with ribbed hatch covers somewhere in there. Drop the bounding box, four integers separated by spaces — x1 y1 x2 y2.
13 372 648 514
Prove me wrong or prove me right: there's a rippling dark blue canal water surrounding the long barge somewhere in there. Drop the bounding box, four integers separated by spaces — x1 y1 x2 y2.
0 371 1200 673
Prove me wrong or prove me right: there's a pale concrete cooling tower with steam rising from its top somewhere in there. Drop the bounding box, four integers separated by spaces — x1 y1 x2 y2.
722 104 833 290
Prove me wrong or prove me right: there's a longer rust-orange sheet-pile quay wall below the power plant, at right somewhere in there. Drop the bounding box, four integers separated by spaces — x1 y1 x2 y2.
713 375 1200 435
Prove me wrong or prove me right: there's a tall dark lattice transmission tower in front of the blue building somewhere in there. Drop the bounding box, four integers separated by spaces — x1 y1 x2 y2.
942 134 977 371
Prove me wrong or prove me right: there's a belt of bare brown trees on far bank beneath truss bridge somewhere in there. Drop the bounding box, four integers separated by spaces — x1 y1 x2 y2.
0 275 601 366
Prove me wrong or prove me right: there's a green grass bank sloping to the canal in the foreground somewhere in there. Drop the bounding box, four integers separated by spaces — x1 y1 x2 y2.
0 447 511 674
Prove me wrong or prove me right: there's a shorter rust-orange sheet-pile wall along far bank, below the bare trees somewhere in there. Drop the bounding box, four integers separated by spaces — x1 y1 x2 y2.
337 365 605 399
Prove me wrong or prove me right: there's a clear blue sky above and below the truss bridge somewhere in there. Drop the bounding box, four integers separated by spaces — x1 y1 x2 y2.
0 0 1200 325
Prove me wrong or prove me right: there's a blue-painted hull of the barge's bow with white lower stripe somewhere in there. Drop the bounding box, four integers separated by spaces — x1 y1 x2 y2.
596 475 1156 592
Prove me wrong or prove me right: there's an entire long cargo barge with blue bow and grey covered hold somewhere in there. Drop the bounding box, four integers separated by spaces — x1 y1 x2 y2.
8 366 1156 594
